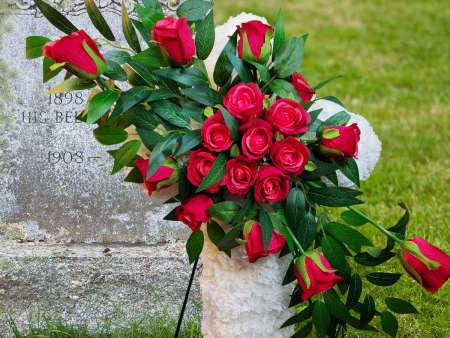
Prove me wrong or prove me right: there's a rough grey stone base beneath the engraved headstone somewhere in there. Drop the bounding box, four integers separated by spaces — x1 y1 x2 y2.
0 241 202 334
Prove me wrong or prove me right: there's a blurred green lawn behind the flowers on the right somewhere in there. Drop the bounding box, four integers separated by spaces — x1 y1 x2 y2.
214 0 450 337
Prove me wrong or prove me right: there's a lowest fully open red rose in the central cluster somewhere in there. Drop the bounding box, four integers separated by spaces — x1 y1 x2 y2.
255 165 289 203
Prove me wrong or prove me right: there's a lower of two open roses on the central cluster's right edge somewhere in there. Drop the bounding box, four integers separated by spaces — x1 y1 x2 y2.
270 136 310 177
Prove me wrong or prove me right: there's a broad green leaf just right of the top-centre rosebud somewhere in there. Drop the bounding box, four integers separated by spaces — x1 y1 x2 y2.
273 37 305 79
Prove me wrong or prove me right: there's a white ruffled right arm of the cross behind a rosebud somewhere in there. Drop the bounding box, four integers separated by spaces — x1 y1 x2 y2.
309 100 381 189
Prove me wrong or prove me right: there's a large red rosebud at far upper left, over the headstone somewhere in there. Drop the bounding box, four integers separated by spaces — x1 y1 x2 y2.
42 30 108 81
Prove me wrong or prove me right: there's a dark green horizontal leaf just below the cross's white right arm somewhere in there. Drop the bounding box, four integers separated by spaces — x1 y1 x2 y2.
308 187 364 207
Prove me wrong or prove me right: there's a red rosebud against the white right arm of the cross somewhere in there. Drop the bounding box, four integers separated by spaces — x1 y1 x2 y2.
319 123 361 158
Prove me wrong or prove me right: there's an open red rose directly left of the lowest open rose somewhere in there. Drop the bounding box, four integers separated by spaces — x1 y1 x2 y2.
225 155 258 195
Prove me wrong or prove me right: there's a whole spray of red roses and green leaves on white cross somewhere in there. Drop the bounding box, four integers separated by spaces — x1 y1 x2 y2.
26 0 450 337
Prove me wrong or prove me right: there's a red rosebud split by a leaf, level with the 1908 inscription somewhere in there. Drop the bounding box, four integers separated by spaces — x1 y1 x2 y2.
135 157 180 196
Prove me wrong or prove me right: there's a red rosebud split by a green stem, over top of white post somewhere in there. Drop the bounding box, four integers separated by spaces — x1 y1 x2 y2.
244 220 286 263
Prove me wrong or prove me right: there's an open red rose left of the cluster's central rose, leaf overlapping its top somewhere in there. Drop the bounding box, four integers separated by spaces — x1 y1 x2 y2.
202 110 233 152
